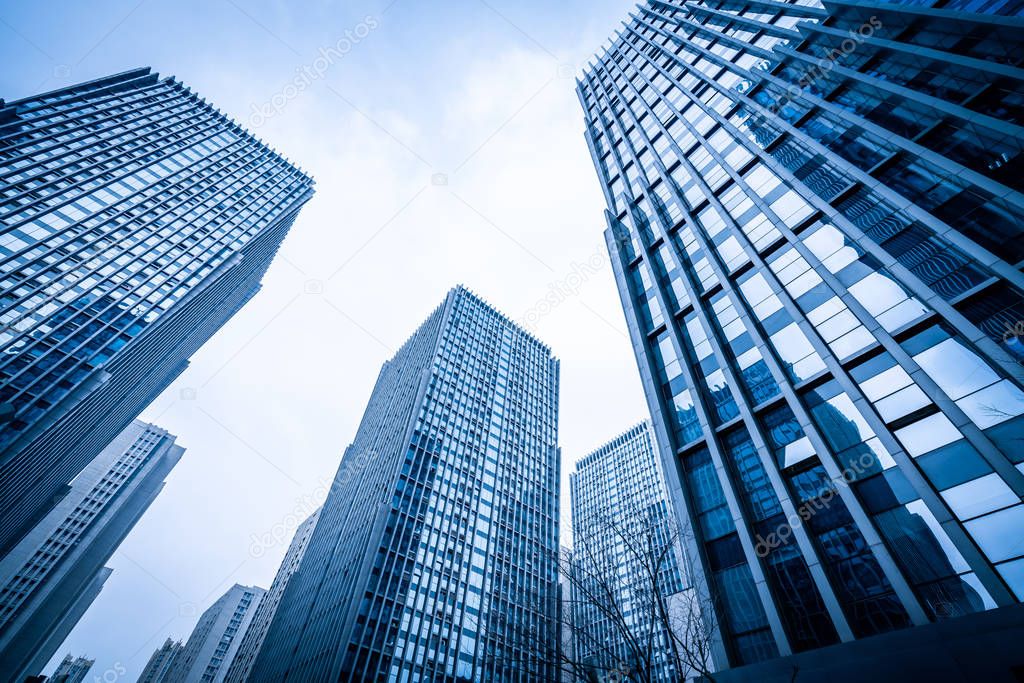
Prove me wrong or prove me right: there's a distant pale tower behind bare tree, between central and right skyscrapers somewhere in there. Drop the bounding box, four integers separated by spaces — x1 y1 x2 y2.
563 422 687 683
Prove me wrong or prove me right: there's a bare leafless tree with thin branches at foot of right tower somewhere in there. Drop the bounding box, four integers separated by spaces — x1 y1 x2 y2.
479 513 717 683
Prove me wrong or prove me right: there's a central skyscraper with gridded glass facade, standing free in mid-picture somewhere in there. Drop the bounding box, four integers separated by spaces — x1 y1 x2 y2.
251 287 559 682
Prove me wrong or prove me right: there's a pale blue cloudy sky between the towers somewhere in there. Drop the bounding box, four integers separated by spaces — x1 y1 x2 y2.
0 0 647 681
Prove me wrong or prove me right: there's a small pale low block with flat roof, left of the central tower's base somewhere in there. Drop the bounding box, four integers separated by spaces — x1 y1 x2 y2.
161 584 266 683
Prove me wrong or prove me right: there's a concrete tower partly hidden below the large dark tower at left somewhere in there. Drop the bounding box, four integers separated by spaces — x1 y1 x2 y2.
0 420 184 681
